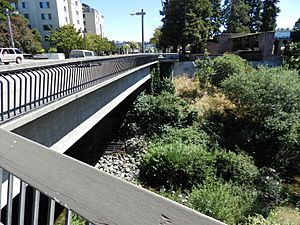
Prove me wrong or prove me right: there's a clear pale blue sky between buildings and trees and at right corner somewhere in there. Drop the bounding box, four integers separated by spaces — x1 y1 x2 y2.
82 0 300 41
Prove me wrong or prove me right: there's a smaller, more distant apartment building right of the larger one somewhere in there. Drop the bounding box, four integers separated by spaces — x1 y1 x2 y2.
82 3 104 37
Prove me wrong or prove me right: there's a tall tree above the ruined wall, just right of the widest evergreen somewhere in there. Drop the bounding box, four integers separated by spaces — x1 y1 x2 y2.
223 0 251 33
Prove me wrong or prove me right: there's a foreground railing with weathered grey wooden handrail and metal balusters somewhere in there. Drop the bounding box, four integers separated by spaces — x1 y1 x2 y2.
0 130 223 225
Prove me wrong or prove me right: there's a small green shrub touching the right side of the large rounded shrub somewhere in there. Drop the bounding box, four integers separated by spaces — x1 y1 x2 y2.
216 151 259 186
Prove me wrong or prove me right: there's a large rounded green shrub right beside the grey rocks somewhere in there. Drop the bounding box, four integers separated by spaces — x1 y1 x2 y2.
140 142 215 189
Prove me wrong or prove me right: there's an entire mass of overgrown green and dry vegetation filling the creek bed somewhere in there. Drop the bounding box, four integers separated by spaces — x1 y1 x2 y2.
120 60 300 225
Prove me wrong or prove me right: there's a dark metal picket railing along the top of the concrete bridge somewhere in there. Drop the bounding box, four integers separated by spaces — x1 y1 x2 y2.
0 54 158 123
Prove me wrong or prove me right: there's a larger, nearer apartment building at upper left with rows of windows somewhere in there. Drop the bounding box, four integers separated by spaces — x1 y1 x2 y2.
10 0 84 48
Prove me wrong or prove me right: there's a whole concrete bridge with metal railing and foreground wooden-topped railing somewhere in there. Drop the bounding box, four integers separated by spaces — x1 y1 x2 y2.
0 54 222 225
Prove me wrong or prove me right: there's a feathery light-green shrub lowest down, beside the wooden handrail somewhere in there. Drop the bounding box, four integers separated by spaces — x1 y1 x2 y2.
188 180 255 225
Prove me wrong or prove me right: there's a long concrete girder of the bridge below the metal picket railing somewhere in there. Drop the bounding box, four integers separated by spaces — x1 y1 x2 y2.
1 62 157 153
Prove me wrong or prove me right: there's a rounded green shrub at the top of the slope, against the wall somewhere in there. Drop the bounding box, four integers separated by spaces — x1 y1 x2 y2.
210 54 251 86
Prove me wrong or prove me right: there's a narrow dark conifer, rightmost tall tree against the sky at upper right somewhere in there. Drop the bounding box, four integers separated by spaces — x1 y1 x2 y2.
260 0 280 31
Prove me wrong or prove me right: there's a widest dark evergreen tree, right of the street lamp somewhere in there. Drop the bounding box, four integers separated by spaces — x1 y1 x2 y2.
161 0 220 54
